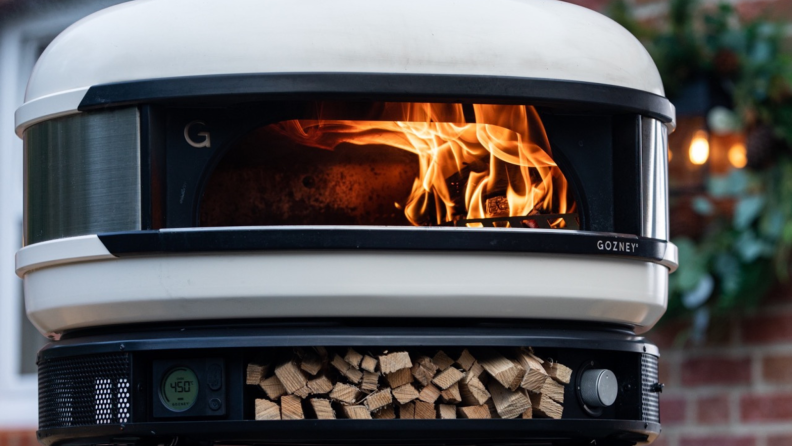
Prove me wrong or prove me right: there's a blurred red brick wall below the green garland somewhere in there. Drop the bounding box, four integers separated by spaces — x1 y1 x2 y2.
649 286 792 446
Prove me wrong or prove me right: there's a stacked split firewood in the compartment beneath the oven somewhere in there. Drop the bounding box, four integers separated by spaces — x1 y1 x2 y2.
247 347 572 420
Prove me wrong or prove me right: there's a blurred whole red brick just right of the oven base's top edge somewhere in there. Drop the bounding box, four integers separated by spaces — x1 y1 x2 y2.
681 357 751 386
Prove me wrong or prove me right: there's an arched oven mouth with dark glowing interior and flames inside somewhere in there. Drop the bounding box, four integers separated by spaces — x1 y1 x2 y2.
200 102 580 229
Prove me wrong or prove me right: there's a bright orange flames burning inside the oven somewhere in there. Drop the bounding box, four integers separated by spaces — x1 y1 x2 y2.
275 103 575 228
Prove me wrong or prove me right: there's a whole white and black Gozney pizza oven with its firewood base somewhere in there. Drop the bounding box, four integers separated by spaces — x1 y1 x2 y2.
16 0 677 445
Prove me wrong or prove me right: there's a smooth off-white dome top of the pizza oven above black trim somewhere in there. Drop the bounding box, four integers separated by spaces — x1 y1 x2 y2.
16 0 664 135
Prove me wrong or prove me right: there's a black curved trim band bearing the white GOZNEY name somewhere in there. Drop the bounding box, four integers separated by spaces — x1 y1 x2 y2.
98 226 668 263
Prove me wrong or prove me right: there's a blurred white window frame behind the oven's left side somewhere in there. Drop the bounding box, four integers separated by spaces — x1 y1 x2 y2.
0 0 125 430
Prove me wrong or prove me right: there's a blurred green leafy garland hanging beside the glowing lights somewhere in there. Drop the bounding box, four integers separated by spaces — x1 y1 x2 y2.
608 0 792 338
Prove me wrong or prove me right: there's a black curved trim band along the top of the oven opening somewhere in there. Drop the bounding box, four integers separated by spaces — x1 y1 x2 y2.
78 72 676 123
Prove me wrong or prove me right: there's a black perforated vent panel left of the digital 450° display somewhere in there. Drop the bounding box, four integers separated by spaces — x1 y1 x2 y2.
39 353 131 429
